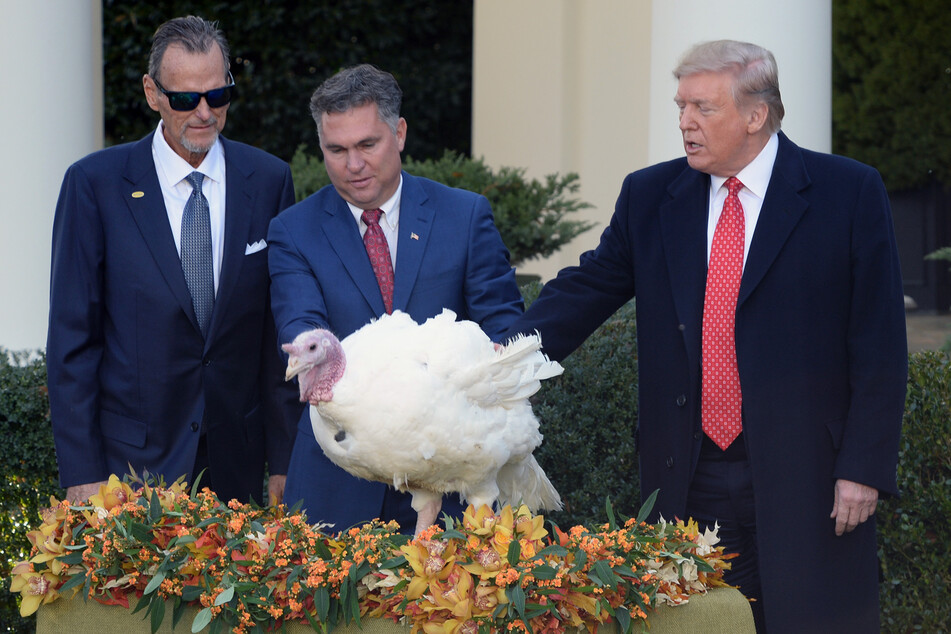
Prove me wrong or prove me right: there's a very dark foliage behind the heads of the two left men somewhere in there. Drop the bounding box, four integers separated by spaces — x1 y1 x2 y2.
102 0 472 160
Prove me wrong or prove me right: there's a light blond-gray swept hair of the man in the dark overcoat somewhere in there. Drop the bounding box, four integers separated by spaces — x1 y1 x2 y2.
674 40 786 134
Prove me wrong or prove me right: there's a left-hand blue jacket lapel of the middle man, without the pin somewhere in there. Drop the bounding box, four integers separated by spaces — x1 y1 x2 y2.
322 192 386 315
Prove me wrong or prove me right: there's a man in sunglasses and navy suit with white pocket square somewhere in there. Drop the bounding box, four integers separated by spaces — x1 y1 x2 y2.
47 16 300 502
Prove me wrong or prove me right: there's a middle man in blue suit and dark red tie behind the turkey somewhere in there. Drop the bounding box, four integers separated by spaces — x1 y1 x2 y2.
268 64 522 531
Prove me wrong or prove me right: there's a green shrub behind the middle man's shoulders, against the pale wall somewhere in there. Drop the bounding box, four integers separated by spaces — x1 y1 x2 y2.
290 147 594 266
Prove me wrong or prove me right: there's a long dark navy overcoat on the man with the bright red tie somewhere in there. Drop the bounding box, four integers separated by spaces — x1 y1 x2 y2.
498 134 907 632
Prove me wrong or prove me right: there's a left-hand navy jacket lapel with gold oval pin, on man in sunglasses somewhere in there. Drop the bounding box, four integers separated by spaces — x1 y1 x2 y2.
122 133 199 330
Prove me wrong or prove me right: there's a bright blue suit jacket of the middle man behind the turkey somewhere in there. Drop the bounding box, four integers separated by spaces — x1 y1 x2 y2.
268 172 522 530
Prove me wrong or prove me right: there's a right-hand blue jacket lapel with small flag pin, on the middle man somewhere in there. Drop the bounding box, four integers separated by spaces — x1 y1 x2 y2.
393 172 435 311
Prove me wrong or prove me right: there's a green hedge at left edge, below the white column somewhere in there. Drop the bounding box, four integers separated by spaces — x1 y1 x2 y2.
0 348 62 632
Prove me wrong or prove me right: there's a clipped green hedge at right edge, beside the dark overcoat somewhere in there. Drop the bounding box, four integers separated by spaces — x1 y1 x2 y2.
876 352 951 633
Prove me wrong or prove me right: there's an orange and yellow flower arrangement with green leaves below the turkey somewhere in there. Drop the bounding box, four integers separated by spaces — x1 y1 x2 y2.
10 476 732 634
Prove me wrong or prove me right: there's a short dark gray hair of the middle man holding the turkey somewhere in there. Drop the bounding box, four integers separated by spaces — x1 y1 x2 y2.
310 64 403 137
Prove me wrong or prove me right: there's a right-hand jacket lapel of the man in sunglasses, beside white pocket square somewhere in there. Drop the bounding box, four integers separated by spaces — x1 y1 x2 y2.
206 139 254 341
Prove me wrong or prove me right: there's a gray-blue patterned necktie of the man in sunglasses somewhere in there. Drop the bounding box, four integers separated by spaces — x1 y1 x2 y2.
182 172 215 336
